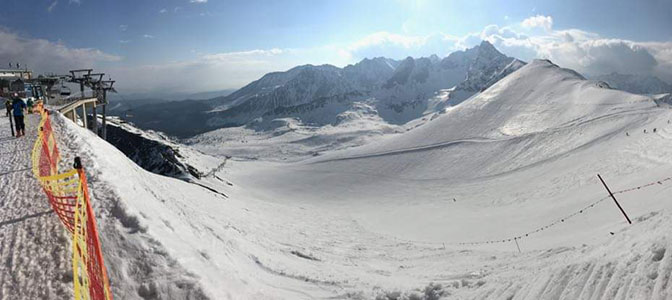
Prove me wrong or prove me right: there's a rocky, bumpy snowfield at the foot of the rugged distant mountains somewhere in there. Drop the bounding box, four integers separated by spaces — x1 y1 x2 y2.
187 102 404 161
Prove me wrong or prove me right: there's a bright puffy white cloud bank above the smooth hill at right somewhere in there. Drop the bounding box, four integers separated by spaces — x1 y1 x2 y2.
458 16 672 82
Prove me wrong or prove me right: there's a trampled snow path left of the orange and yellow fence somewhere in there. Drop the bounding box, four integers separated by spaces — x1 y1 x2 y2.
0 115 72 299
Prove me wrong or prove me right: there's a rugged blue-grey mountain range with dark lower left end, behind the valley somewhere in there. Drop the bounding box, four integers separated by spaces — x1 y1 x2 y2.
119 42 525 138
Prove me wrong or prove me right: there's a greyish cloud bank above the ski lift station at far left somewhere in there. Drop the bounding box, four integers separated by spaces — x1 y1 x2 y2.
0 29 121 73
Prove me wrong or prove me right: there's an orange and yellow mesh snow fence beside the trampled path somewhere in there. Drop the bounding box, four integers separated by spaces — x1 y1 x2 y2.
32 105 112 300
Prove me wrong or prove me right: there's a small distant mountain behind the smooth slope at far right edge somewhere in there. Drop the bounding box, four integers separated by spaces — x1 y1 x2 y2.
592 73 672 94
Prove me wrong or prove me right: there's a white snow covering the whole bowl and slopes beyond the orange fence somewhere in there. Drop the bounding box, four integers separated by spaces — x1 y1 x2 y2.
3 56 672 299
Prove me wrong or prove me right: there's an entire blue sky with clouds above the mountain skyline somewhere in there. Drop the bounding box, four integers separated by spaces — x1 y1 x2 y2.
0 0 672 92
